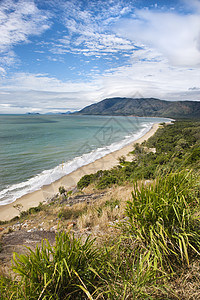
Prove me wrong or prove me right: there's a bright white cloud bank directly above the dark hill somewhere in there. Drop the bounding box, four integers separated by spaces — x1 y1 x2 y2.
98 49 200 100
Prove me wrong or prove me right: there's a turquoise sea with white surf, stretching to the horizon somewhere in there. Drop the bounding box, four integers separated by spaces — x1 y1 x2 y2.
0 114 169 205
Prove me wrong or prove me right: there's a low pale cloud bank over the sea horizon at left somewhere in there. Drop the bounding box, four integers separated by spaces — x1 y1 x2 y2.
0 73 100 113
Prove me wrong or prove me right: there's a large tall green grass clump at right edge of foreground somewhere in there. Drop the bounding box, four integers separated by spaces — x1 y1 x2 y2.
126 171 200 269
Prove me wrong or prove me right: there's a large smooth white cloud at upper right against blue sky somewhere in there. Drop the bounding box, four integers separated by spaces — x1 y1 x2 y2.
115 9 200 66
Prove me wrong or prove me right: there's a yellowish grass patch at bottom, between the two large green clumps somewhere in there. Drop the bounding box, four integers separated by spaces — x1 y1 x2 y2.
98 236 165 300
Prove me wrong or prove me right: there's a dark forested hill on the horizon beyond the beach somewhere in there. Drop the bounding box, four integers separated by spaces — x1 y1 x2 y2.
76 98 200 118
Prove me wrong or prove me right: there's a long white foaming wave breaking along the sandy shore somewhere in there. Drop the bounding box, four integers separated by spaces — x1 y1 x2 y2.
0 123 153 205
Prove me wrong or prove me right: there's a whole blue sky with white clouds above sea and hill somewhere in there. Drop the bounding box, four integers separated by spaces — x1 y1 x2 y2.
0 0 200 114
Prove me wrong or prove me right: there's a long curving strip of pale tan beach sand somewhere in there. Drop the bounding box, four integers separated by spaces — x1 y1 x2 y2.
0 123 159 221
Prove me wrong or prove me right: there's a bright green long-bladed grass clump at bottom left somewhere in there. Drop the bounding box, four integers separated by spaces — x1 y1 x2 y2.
1 233 104 300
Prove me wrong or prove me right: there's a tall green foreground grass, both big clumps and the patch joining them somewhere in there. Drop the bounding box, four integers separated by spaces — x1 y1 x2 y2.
0 171 200 300
